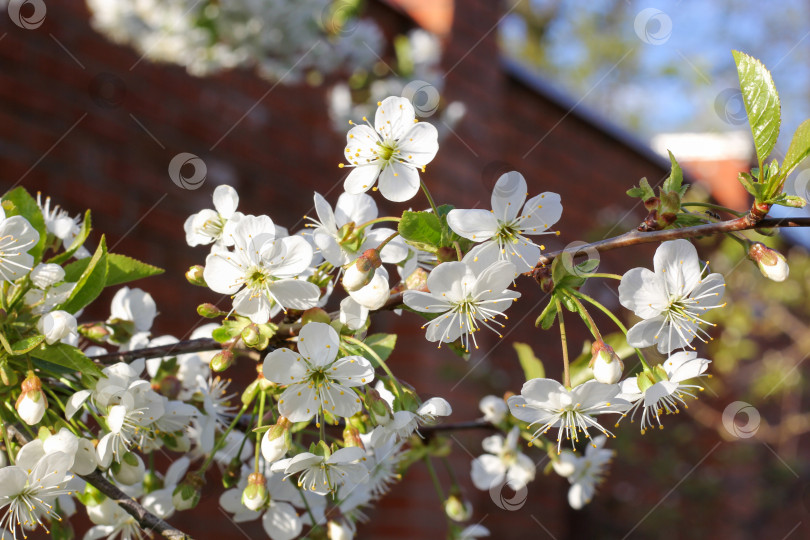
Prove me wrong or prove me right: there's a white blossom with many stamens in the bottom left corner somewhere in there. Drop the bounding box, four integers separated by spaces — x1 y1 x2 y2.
0 441 72 539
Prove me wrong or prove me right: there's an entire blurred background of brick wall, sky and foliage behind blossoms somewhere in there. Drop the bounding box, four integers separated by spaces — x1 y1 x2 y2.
0 0 810 540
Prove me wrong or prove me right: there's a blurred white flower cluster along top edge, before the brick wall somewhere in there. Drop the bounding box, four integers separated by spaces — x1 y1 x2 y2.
87 0 382 84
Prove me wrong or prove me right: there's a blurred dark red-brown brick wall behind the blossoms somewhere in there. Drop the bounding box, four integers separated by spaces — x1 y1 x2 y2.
0 0 665 539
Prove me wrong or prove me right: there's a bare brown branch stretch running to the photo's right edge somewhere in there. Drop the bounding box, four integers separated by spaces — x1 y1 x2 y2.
529 216 810 268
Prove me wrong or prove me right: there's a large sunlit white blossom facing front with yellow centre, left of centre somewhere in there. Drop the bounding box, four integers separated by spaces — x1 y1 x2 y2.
204 216 321 324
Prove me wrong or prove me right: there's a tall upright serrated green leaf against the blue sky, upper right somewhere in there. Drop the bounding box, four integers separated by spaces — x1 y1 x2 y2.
733 51 781 163
